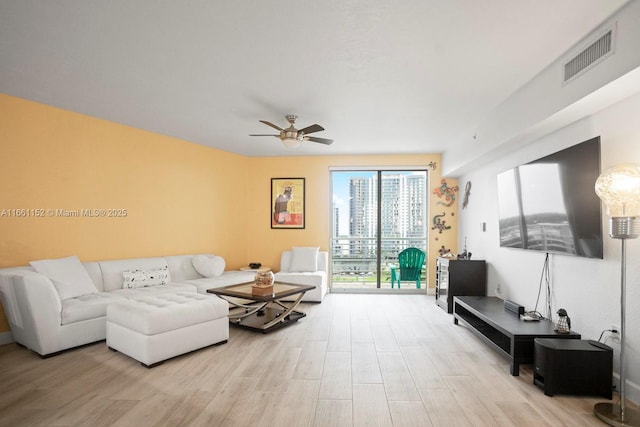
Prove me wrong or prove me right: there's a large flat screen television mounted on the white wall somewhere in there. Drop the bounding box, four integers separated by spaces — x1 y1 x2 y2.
498 136 603 258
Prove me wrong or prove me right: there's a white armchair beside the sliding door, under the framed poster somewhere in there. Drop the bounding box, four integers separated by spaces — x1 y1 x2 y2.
275 251 329 302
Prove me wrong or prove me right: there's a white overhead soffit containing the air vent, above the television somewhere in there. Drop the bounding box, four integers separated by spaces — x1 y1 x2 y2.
442 0 640 176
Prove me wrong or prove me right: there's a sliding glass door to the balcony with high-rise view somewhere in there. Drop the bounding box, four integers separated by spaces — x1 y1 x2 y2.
331 169 428 291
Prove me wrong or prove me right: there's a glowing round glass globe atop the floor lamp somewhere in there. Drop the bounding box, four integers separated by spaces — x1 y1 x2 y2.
596 163 640 217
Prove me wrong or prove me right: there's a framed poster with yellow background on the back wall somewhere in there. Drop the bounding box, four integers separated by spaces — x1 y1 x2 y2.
270 178 305 229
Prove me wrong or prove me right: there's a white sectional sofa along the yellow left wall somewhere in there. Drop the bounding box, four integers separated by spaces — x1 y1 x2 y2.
0 255 254 357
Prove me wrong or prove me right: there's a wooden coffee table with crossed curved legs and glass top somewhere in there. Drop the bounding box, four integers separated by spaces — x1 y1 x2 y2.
207 282 315 334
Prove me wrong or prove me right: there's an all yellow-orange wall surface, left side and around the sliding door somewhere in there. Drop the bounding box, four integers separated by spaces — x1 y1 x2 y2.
0 94 457 333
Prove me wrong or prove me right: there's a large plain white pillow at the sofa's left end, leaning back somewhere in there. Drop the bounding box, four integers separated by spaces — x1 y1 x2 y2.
29 256 98 300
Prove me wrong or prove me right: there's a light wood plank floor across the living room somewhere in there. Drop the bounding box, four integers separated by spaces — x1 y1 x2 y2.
0 294 624 427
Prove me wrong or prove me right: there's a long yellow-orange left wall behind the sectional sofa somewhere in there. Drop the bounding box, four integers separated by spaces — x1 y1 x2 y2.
0 95 248 332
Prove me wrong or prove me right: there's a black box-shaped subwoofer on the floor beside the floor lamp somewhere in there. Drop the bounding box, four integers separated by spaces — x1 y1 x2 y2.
533 338 613 399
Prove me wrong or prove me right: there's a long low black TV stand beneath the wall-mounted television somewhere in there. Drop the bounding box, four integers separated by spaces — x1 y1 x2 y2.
453 297 580 376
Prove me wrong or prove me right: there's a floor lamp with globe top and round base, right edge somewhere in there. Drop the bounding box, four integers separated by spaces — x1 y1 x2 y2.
593 163 640 426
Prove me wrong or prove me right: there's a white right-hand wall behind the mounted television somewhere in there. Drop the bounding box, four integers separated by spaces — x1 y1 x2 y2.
458 95 640 403
